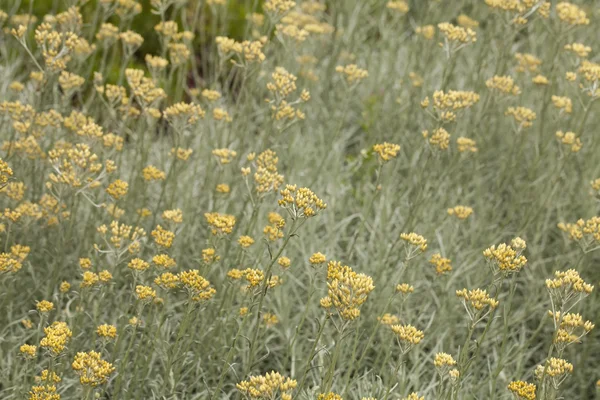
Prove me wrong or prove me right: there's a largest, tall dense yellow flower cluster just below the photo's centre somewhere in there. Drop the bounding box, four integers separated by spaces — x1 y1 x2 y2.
321 261 375 321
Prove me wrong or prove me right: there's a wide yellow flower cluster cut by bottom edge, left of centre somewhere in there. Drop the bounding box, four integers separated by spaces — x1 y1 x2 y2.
236 371 297 400
